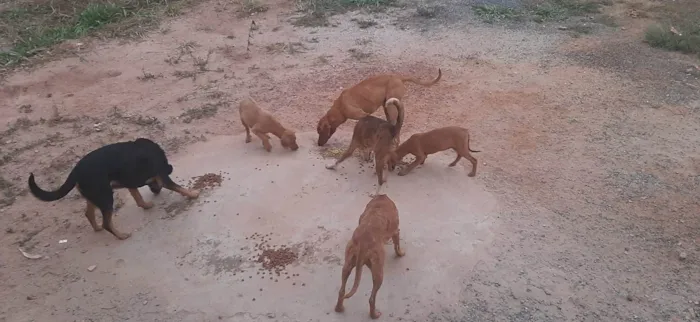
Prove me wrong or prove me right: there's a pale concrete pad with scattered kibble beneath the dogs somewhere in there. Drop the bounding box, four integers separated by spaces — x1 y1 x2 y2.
53 133 497 321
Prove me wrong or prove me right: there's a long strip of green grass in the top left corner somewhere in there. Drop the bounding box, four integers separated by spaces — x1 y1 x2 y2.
0 0 189 67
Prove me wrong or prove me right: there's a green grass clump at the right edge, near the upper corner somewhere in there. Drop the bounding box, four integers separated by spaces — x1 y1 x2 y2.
644 24 700 55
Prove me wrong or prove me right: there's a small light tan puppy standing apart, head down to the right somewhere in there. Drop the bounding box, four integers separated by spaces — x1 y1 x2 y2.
238 98 299 152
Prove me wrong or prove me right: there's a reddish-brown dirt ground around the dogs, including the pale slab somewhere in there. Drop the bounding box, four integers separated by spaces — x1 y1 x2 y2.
0 1 700 321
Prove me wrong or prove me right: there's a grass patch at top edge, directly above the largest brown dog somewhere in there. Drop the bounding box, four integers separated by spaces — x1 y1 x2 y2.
293 0 396 27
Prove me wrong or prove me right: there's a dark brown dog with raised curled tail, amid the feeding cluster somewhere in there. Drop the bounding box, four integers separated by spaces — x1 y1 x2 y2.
326 97 404 194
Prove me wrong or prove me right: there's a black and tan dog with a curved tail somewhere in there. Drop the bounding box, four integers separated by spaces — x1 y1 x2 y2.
29 138 199 239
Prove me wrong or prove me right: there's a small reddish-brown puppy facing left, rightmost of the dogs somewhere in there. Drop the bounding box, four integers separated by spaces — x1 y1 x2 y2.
391 126 481 177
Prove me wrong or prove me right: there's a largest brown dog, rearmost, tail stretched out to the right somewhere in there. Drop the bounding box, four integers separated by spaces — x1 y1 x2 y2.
316 69 442 146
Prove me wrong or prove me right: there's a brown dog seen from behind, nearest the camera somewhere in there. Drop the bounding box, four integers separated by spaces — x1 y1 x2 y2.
335 195 406 319
